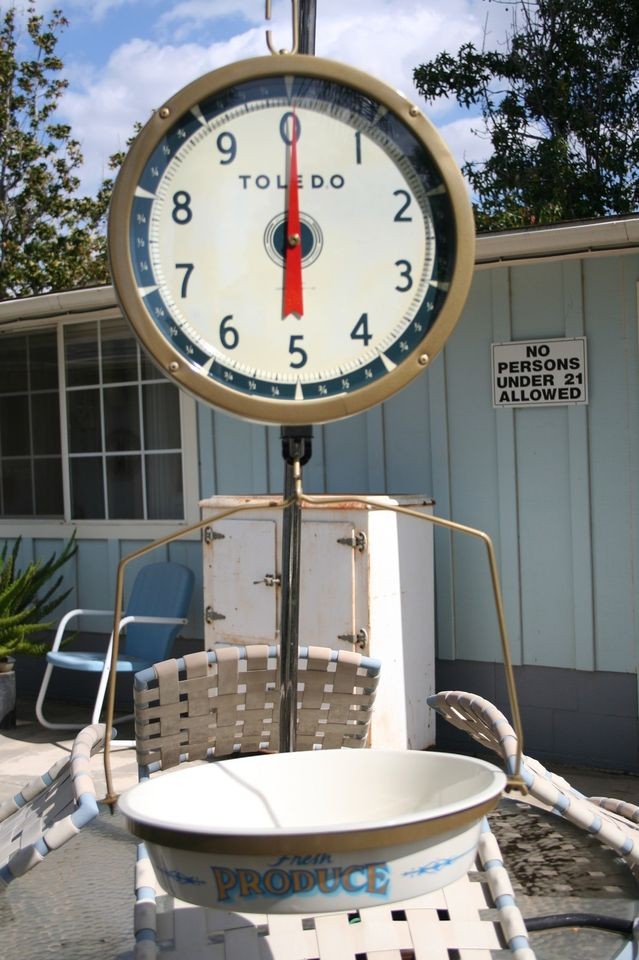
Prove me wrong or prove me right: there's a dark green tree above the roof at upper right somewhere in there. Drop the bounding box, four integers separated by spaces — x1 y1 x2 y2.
414 0 639 230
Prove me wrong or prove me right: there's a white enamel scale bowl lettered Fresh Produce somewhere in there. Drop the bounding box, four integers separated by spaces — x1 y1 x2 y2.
120 749 506 913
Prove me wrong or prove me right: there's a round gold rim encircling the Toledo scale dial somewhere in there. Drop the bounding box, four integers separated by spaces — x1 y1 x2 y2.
108 54 475 426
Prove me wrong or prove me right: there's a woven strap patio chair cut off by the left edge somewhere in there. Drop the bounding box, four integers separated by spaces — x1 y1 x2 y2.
0 724 105 890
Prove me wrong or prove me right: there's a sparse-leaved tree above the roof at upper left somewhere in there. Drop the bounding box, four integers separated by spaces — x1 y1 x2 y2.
0 0 110 300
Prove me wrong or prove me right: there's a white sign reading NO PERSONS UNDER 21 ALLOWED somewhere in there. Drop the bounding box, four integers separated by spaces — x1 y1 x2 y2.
492 337 588 407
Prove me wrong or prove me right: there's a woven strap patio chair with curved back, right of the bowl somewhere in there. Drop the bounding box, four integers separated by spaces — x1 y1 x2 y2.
428 690 639 877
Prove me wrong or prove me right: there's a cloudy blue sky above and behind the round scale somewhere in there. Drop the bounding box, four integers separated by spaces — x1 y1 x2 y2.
23 0 510 191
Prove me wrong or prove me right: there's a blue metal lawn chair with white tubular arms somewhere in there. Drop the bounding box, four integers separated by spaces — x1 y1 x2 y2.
36 563 195 730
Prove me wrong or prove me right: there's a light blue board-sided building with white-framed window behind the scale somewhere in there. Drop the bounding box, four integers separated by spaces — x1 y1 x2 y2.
0 216 639 771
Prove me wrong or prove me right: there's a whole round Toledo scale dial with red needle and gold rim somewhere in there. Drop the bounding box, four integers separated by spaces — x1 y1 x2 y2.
109 55 474 424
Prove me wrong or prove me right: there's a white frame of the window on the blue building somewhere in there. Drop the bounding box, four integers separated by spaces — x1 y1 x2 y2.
0 307 200 542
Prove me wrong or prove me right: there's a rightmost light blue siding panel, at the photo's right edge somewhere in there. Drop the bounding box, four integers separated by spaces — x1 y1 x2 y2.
584 257 639 671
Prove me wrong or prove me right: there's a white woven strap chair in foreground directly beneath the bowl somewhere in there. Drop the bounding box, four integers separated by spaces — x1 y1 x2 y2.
134 822 535 960
